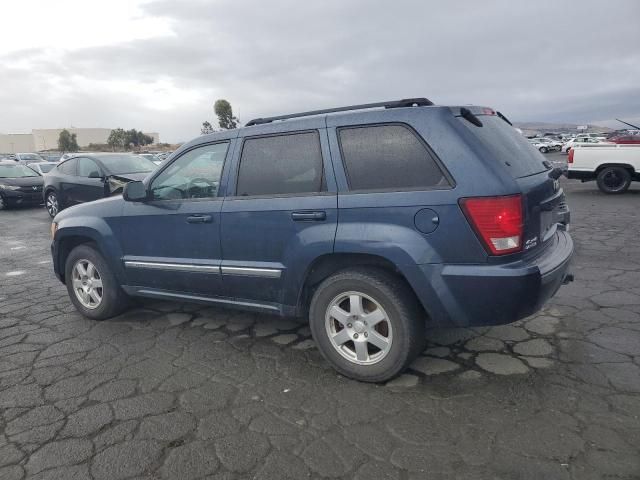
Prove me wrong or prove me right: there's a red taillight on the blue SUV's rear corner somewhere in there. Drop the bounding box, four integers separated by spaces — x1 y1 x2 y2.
460 195 522 255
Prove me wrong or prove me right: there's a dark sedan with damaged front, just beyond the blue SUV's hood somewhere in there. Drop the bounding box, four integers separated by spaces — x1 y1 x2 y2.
44 153 156 217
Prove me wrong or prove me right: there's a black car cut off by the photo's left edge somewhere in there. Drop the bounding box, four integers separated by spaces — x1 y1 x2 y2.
0 160 43 210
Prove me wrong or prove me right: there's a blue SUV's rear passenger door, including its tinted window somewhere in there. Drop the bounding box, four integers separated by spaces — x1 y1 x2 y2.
221 123 337 309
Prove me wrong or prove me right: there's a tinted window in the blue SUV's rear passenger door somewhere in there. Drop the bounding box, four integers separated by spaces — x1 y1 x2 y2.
236 132 323 196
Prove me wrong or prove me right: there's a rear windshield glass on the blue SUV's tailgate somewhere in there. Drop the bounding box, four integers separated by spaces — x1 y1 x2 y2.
459 115 547 178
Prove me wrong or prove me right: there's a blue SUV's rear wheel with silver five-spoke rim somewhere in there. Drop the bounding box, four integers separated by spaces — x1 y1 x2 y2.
309 268 425 382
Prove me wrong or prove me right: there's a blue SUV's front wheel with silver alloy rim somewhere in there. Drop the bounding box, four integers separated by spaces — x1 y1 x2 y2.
64 244 129 320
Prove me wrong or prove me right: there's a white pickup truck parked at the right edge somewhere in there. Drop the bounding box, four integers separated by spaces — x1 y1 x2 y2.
567 143 640 193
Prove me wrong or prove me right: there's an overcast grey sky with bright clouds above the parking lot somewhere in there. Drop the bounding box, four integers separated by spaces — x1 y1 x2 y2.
0 0 640 142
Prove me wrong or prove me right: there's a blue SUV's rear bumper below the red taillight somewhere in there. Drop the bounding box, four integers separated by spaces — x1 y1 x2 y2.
420 229 573 326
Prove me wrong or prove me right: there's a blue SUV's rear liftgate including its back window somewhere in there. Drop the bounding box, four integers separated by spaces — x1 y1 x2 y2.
458 109 569 254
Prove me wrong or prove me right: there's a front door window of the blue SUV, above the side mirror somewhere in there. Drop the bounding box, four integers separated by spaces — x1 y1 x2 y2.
151 142 229 200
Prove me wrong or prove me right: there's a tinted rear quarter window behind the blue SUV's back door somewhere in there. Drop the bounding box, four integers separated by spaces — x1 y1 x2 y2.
338 125 450 190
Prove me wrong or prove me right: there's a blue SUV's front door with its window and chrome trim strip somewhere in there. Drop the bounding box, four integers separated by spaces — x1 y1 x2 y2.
122 141 231 296
